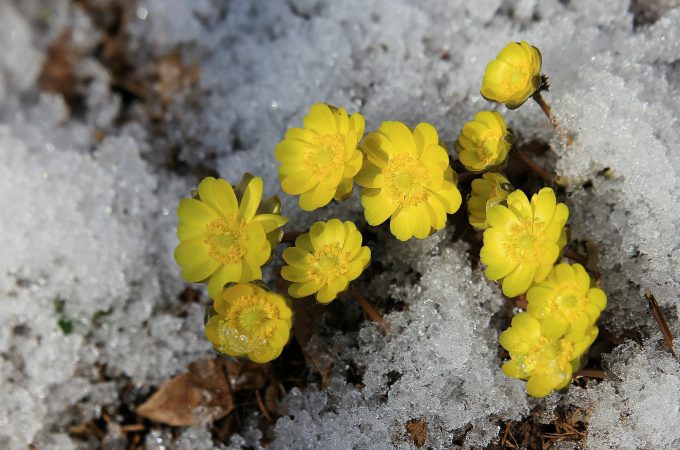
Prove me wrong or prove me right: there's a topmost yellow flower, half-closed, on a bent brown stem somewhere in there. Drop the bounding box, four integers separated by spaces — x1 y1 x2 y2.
481 41 541 109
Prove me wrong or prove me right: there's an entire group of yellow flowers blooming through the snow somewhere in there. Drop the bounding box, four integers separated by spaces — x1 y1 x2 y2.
175 37 606 397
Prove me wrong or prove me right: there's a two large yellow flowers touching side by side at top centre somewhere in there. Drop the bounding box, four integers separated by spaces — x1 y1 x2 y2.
274 103 462 241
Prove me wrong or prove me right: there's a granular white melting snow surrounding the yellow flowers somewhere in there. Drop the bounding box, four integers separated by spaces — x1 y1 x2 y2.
0 0 680 449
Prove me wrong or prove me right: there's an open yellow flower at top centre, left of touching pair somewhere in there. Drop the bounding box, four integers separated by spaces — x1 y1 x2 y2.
274 103 364 211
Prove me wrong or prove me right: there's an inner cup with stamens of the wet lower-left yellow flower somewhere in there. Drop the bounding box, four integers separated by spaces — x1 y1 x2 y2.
218 295 279 353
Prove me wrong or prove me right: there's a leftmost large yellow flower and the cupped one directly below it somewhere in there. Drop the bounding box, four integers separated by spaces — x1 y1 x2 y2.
175 174 292 362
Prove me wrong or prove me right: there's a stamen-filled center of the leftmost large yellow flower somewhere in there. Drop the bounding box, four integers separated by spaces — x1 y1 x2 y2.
205 214 248 264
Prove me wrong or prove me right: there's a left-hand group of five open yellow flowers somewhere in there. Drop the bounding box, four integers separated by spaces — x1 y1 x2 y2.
175 103 462 362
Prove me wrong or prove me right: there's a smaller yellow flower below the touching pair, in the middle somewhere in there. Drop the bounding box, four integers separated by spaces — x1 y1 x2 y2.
281 219 371 303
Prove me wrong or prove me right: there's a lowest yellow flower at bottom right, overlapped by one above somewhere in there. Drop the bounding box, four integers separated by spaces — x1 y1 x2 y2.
499 312 598 397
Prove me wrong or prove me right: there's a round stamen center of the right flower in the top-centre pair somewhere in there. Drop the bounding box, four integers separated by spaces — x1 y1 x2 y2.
383 153 429 207
